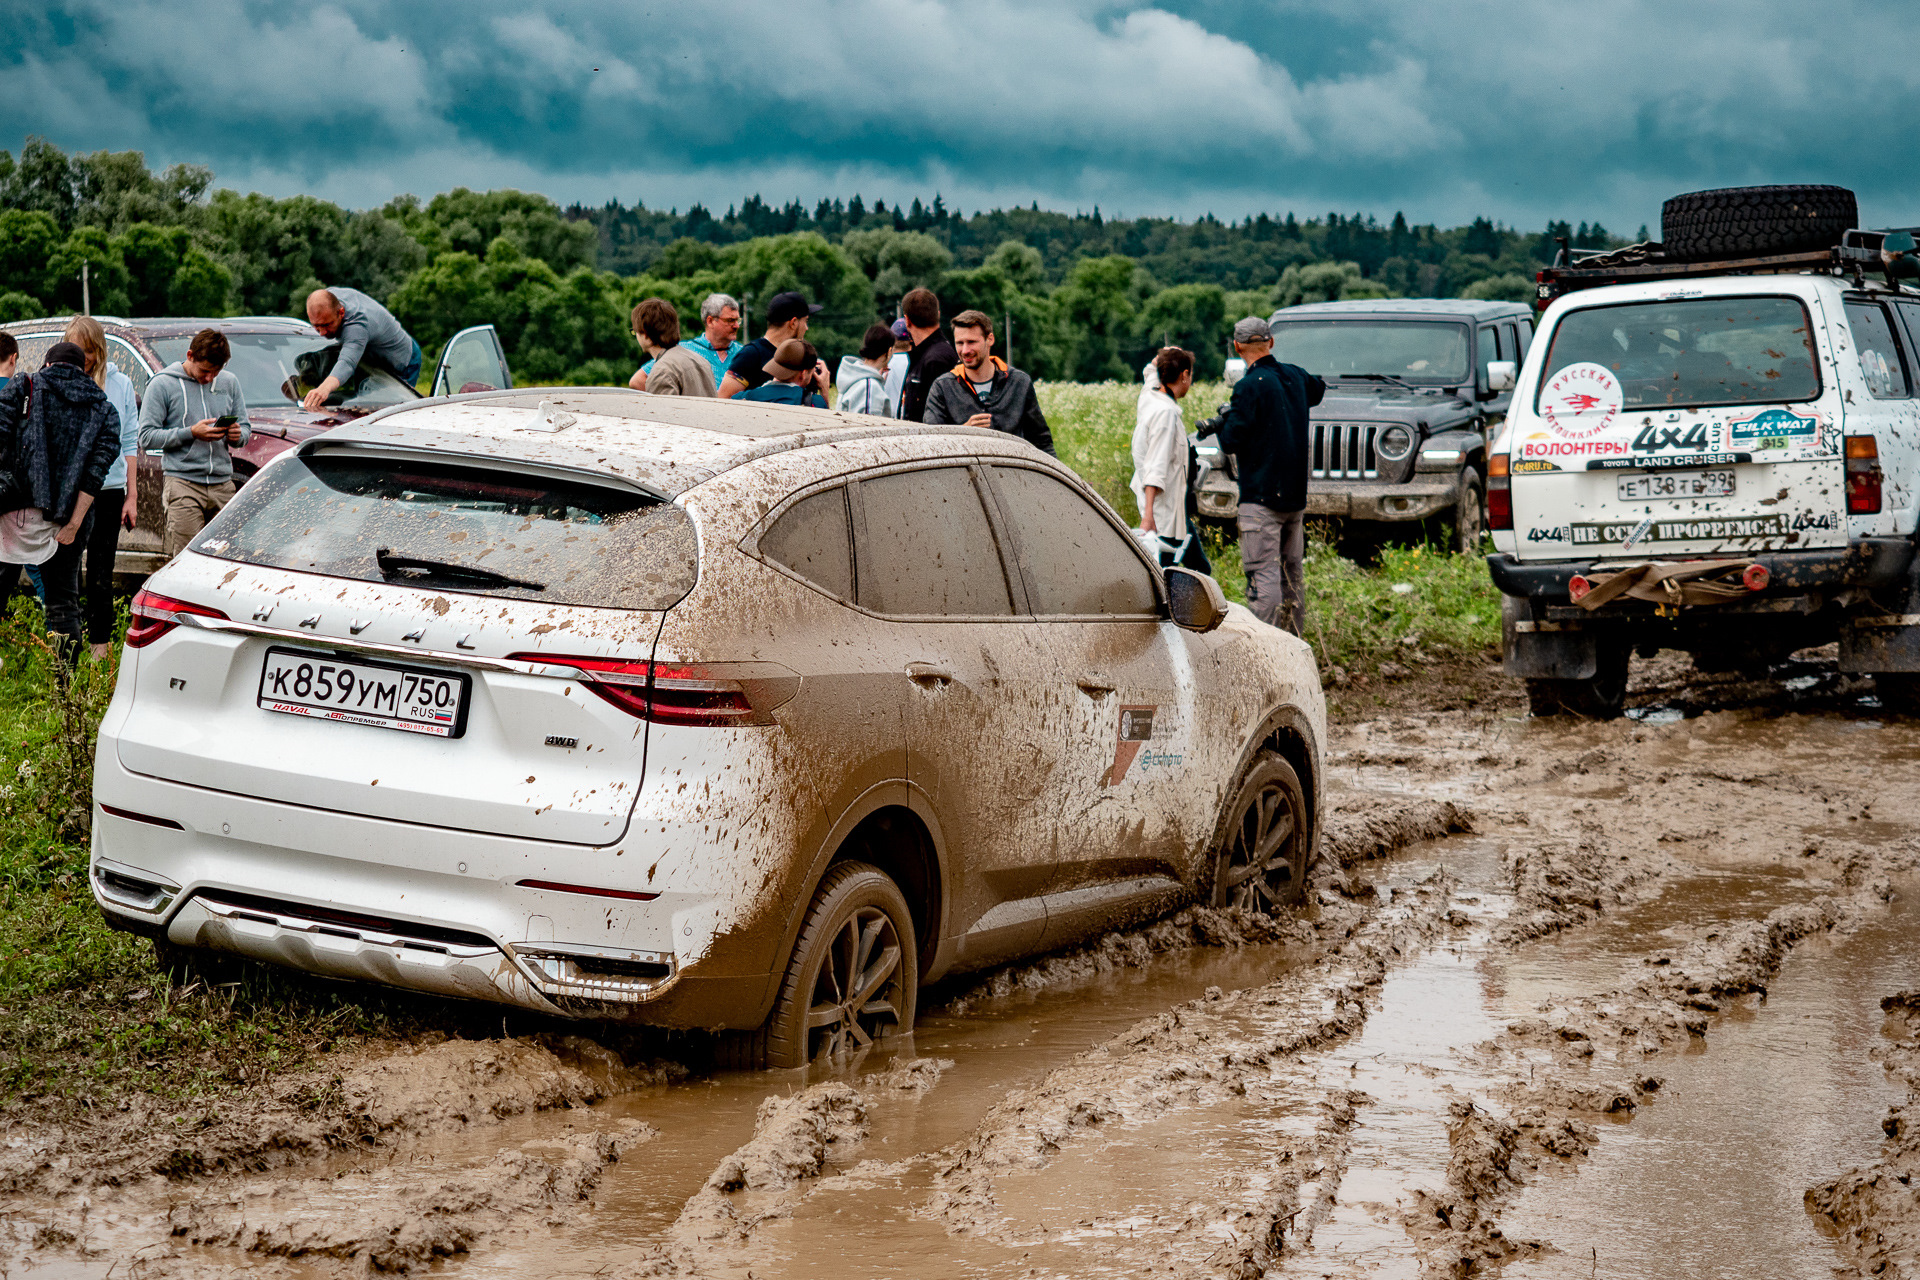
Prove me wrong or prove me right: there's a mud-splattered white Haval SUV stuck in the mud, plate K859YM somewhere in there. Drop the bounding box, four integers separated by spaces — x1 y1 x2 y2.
92 390 1325 1065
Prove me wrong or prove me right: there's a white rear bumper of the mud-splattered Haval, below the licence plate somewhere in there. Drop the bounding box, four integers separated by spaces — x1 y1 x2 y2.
88 745 770 1027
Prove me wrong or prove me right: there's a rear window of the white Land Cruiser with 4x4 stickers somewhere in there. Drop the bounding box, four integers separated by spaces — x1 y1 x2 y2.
1540 297 1820 409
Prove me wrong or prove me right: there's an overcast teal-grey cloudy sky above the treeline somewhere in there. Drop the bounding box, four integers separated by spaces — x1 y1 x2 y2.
0 0 1920 234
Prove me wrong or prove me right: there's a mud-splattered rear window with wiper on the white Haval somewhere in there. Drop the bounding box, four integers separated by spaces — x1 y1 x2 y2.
194 451 699 608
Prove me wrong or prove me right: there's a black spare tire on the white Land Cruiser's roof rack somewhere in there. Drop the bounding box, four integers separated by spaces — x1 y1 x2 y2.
1661 186 1860 261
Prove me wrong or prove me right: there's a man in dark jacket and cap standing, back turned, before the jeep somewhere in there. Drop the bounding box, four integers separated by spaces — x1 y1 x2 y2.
1200 317 1327 635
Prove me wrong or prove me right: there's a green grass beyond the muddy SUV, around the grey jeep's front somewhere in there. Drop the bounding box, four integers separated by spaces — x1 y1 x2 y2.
1039 382 1500 676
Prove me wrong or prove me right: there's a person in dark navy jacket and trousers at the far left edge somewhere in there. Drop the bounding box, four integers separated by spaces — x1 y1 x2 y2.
0 342 121 666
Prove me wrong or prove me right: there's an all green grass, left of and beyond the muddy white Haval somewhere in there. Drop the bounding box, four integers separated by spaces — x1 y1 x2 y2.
0 384 1500 1109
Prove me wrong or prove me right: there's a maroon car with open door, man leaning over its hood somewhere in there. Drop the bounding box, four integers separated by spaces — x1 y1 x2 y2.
0 315 513 578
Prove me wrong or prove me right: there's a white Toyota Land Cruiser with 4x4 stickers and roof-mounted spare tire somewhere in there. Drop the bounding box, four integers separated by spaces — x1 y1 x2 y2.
1488 186 1920 716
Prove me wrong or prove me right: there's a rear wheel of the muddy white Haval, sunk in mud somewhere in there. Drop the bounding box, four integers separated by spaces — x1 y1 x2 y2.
720 862 920 1069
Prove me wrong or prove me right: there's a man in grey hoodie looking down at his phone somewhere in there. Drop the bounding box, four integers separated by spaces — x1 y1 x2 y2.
140 328 253 557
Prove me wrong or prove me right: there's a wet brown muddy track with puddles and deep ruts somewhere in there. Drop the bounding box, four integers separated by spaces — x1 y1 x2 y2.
11 668 1920 1280
